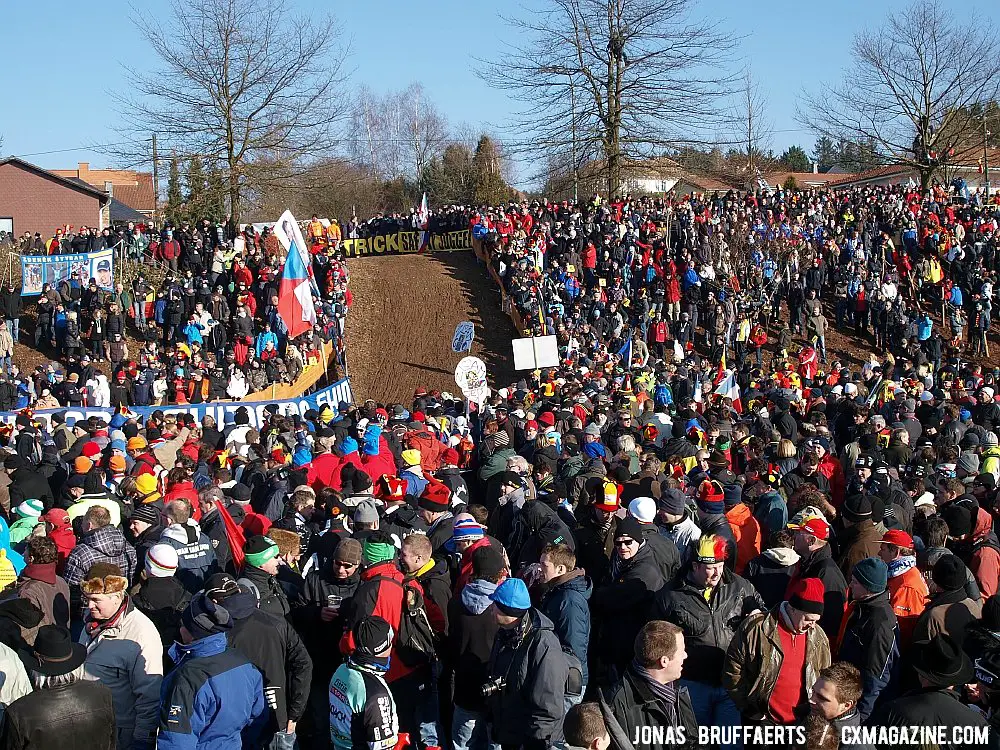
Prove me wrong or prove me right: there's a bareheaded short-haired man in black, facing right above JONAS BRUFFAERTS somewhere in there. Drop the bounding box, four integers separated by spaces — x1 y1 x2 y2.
599 620 698 748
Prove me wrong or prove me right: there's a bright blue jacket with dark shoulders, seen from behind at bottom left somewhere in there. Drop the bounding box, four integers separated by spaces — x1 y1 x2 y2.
156 633 267 750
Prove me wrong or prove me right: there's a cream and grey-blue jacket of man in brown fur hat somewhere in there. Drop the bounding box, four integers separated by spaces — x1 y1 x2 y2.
80 602 163 748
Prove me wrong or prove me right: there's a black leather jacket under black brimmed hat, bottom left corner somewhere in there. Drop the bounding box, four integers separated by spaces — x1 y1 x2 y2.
0 680 118 750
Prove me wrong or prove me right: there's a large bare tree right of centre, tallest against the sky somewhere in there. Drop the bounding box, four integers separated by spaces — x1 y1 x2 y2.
478 0 734 195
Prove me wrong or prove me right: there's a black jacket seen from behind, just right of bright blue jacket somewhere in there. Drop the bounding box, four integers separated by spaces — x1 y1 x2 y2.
223 592 312 737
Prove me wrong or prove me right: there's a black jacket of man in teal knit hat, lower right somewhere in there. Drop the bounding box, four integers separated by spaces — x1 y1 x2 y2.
838 591 899 721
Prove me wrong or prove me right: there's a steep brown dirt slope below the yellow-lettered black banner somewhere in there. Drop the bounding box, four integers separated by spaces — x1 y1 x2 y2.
346 251 515 404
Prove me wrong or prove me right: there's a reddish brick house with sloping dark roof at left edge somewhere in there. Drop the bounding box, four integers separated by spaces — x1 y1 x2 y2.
0 156 110 238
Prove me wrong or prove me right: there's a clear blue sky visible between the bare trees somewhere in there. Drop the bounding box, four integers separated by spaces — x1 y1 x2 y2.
0 0 1000 187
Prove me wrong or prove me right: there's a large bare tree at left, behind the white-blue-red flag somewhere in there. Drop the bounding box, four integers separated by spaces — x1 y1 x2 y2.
110 0 348 221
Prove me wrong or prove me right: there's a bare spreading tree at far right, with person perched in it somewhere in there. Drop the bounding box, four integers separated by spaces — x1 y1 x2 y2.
798 0 1000 187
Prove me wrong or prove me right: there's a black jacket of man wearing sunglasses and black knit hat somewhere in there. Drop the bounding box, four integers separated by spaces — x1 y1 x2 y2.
590 544 665 669
